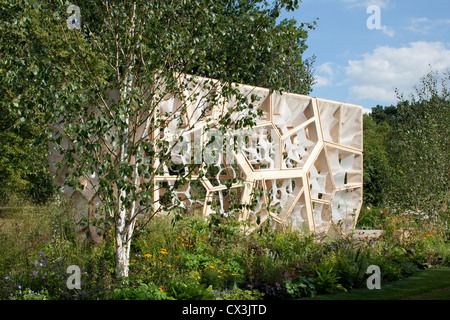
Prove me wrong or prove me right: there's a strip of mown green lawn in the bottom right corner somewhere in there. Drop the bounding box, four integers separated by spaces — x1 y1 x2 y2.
302 267 450 300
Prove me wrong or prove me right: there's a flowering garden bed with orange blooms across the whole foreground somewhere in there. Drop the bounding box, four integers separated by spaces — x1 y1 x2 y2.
0 200 450 300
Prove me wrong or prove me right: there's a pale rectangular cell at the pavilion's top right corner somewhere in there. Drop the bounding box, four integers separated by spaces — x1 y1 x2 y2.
340 104 362 150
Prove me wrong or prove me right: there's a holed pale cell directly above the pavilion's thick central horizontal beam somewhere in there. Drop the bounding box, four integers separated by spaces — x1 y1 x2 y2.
282 122 318 169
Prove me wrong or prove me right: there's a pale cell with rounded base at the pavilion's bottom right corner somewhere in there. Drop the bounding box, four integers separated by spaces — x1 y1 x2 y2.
331 188 362 232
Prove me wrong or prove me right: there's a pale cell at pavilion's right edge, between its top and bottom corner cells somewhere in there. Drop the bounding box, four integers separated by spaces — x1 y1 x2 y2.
326 146 362 188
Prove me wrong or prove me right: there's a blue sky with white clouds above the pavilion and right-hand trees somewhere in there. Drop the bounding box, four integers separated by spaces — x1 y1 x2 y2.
282 0 450 112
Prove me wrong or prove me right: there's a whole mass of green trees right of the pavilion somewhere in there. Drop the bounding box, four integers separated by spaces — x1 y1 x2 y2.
364 71 450 217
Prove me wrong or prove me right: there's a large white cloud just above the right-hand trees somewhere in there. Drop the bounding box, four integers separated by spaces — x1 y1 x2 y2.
345 41 450 103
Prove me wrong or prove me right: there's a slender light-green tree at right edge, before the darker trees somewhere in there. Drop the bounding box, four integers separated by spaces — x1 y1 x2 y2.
388 71 450 214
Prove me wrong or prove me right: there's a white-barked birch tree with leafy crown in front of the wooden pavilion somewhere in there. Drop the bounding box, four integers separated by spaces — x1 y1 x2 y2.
1 0 312 276
